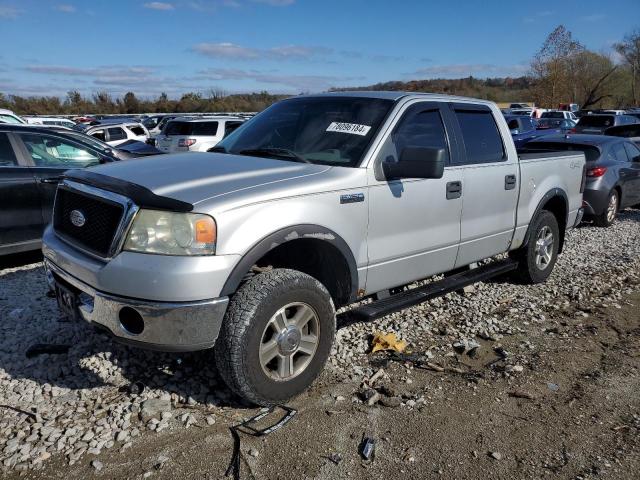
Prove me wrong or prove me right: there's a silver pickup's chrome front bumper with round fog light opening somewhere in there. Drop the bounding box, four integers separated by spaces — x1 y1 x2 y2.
45 258 229 352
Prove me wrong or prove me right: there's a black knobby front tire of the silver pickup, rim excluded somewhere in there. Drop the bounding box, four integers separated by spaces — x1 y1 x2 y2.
214 269 336 406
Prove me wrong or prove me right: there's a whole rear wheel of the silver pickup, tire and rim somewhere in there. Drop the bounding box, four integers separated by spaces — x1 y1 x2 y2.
511 210 560 283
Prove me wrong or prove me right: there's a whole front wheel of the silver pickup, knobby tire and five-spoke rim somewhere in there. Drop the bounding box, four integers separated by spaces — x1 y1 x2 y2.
214 269 336 406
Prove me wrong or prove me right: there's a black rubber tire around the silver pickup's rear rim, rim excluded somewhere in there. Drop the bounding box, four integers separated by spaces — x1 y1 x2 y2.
510 210 560 284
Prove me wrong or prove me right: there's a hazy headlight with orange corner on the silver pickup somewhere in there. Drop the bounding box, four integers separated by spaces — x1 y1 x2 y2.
124 209 217 255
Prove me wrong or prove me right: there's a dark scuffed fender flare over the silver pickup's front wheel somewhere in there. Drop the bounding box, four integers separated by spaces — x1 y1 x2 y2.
220 224 359 301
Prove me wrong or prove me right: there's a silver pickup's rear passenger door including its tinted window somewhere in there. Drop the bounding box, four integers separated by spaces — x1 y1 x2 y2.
450 103 520 267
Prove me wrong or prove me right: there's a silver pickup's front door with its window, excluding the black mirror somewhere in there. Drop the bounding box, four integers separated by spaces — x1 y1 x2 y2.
366 101 462 293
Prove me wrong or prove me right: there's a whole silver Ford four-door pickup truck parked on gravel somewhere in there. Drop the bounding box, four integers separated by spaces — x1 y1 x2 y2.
43 92 585 405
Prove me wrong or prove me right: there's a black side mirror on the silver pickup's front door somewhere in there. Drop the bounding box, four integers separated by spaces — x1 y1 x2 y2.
382 147 446 180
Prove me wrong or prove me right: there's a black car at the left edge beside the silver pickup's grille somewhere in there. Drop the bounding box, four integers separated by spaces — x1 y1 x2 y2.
0 124 117 255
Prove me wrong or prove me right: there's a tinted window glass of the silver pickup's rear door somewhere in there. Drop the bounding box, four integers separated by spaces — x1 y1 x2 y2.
456 110 505 164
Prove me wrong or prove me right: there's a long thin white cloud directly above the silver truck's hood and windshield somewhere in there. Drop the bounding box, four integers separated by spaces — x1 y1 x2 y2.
192 42 332 60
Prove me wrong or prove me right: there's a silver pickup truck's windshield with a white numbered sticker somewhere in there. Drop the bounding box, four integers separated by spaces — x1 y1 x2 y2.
216 96 393 167
